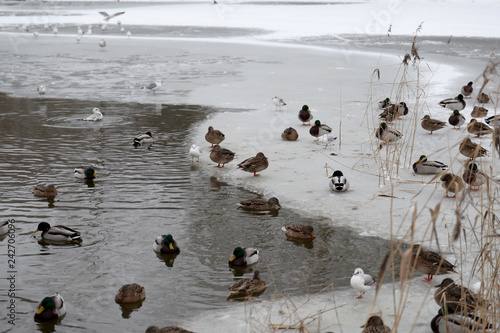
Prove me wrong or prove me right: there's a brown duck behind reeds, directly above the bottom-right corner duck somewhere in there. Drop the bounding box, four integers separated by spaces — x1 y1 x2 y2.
434 278 486 313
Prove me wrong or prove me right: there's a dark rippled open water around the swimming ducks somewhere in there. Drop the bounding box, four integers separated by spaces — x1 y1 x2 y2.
0 94 390 332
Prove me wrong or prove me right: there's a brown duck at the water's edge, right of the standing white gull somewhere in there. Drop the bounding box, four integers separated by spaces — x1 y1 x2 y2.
407 244 456 282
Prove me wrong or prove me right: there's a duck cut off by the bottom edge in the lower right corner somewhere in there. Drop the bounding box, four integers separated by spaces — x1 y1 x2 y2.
431 307 493 333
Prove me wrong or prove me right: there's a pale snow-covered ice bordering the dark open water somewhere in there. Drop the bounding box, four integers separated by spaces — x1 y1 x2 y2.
0 1 500 332
